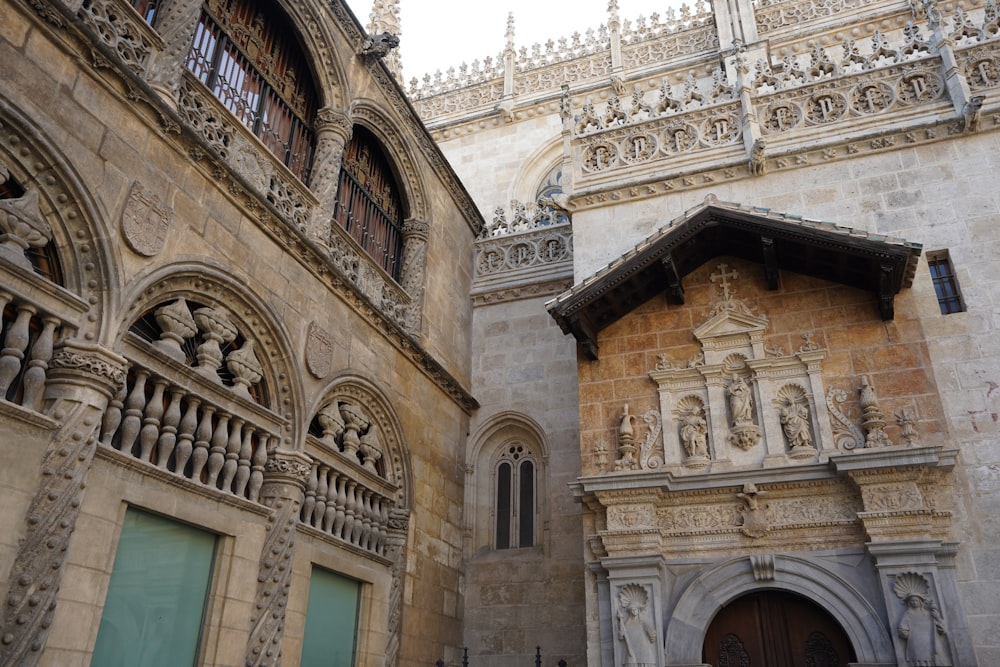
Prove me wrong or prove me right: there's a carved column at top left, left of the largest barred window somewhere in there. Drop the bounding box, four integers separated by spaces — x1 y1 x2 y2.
146 0 202 109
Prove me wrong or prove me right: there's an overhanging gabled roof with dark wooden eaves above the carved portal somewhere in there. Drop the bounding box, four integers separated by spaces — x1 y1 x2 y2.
546 195 921 359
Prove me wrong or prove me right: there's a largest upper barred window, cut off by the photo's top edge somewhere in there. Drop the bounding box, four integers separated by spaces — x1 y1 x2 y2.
185 0 317 181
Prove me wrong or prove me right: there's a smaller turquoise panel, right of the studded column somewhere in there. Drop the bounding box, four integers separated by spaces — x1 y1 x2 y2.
299 567 361 667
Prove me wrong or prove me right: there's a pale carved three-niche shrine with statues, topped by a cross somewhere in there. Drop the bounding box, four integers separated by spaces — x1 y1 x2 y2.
649 264 835 473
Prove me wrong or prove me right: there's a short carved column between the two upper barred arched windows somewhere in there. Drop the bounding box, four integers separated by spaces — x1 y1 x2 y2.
308 107 354 246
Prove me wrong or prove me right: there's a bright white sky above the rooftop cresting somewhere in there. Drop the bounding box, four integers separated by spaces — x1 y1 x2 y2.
348 0 694 84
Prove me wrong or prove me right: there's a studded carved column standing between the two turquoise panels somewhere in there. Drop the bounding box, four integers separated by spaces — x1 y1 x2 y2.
244 449 312 667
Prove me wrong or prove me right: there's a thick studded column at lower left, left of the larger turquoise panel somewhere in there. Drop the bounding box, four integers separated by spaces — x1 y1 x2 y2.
0 340 127 667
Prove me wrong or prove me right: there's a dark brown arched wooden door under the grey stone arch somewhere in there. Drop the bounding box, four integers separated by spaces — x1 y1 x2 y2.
702 591 855 667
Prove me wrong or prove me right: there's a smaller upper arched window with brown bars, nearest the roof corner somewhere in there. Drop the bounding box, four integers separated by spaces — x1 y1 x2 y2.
333 126 403 280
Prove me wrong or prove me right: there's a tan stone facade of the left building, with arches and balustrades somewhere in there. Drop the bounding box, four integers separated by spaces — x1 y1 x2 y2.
0 0 483 667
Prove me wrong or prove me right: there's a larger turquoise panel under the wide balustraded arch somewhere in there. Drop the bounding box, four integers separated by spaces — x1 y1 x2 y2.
91 508 215 667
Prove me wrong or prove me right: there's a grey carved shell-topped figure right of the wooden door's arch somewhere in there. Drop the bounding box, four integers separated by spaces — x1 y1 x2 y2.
892 572 951 667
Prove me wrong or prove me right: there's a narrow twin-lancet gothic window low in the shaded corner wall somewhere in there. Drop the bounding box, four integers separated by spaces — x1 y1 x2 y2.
494 443 537 549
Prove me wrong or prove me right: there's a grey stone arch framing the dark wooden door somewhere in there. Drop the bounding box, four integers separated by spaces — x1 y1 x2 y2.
664 555 896 665
